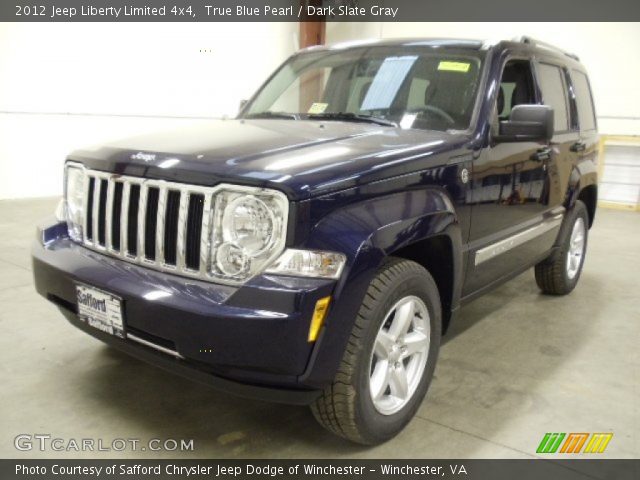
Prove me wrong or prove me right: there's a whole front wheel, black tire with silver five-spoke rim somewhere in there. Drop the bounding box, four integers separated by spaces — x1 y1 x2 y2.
311 259 442 445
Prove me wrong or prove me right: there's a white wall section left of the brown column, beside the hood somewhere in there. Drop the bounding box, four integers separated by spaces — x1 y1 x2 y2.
0 22 298 199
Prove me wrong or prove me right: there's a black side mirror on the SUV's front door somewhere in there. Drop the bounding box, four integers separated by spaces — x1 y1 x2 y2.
494 105 553 143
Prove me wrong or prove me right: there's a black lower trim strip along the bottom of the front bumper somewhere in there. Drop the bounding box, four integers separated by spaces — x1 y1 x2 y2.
60 308 322 405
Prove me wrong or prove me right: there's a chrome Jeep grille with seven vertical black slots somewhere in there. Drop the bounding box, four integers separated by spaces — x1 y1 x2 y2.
83 170 212 280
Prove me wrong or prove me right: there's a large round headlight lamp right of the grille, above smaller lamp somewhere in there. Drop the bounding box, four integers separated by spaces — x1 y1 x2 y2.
222 195 275 256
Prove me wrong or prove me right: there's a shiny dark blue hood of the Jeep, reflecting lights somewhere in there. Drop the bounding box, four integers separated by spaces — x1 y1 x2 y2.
69 119 467 199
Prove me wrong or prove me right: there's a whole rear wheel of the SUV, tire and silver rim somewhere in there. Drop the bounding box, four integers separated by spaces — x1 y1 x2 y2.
535 200 589 295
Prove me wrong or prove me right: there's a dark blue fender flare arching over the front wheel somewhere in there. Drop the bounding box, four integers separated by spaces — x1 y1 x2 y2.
299 187 462 388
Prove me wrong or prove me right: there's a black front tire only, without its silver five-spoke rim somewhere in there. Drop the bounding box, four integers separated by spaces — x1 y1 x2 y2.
311 258 442 445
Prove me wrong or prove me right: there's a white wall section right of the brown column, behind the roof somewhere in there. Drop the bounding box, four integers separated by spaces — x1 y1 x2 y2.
327 22 640 135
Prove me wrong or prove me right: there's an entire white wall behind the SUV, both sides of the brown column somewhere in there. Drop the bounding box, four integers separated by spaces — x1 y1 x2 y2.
0 22 640 199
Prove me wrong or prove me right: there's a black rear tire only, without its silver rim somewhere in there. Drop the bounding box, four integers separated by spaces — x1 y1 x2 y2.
535 200 589 295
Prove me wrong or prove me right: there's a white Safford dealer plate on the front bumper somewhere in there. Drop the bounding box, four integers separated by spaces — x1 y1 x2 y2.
76 284 125 338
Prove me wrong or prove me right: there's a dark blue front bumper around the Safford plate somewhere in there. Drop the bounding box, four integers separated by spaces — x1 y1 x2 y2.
32 221 336 404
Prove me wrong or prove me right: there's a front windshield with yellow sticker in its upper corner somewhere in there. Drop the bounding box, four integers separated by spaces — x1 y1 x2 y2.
243 46 484 131
